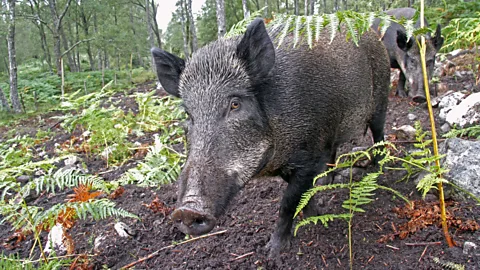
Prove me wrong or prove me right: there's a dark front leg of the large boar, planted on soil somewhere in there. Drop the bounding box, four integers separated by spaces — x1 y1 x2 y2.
267 155 329 258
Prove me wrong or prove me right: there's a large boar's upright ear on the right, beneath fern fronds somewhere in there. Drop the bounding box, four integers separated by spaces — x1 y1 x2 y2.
236 19 275 80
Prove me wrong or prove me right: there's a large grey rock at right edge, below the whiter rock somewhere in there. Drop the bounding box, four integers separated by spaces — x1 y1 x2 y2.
443 138 480 197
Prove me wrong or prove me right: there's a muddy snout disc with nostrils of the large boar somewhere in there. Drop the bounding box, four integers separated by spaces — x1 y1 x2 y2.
172 207 216 235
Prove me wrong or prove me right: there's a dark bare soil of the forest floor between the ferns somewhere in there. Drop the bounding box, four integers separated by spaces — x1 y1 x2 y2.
0 59 480 269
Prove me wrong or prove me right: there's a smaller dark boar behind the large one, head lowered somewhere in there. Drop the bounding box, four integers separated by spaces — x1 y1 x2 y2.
372 8 443 103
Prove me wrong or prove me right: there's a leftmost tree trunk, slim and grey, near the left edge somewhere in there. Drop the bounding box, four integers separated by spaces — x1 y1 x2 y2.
7 0 22 113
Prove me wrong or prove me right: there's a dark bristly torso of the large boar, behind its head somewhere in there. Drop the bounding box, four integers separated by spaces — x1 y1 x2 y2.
264 28 390 166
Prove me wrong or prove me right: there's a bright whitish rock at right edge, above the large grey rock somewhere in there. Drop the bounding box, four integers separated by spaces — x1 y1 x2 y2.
446 93 480 128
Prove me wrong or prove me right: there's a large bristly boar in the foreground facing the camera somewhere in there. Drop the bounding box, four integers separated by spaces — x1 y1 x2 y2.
152 19 390 256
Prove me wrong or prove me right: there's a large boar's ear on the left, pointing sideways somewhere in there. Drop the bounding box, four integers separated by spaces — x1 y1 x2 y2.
151 48 185 97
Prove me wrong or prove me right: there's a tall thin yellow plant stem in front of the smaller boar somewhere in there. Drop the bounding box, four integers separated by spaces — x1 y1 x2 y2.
420 0 455 247
